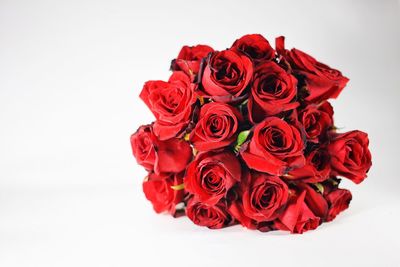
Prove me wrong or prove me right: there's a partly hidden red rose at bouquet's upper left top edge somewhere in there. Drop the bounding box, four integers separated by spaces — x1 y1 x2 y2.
171 45 214 79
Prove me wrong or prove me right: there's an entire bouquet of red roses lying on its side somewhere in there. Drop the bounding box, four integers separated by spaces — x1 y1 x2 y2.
131 34 371 233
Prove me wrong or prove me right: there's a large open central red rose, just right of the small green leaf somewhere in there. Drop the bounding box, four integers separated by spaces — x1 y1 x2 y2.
240 117 305 175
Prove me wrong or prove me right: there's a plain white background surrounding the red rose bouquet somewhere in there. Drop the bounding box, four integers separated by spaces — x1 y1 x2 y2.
0 0 400 267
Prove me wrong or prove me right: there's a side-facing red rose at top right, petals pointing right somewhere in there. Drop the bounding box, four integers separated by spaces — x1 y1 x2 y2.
276 36 349 103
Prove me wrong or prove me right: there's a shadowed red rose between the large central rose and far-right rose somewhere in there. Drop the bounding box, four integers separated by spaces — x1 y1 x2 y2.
284 147 331 183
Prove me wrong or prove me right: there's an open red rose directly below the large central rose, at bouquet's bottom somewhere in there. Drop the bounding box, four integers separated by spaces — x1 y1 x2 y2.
229 172 289 229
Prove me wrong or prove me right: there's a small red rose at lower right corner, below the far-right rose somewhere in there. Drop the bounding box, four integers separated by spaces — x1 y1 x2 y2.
325 189 352 222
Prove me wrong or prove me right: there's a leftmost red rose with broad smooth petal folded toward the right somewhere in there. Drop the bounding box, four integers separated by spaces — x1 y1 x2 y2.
131 125 193 174
